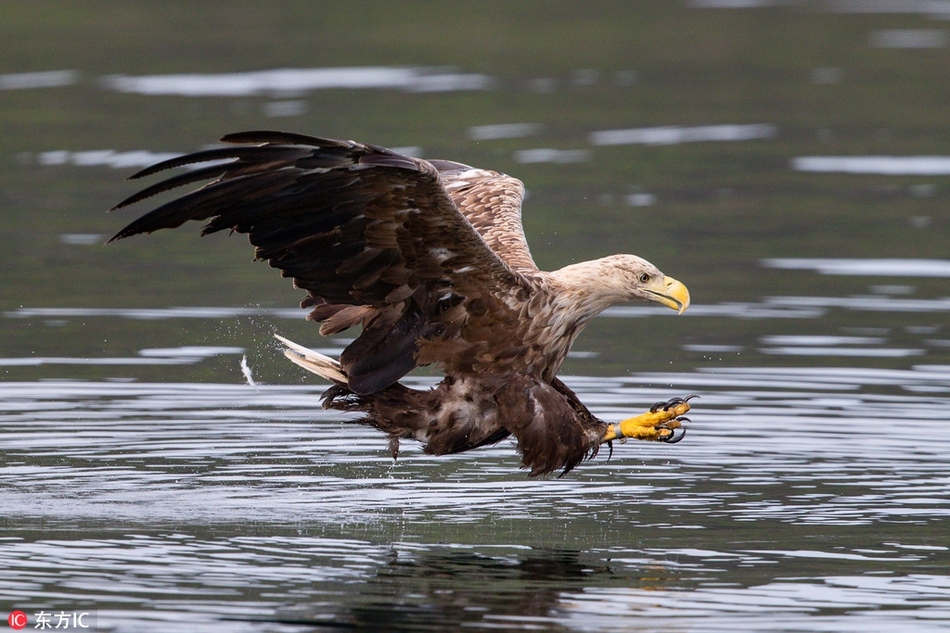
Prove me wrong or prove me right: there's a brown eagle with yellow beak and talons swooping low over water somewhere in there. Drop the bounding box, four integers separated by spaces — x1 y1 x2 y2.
109 131 692 476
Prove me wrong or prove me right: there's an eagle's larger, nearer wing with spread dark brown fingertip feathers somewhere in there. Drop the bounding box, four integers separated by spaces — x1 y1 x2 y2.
110 132 536 394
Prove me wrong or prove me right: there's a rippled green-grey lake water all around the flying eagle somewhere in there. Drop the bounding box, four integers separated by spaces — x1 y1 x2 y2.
0 2 950 633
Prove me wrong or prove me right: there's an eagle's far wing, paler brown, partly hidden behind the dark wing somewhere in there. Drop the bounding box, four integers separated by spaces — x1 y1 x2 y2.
432 160 538 274
